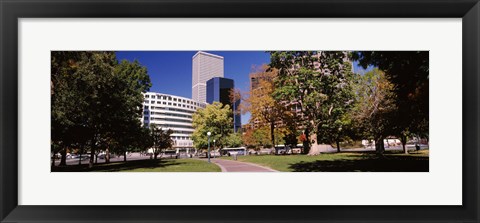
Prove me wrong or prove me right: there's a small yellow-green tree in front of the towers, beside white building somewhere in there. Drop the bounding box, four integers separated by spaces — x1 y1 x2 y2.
192 102 233 152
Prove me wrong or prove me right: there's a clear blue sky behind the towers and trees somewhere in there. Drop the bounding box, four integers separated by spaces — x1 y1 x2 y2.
116 51 363 124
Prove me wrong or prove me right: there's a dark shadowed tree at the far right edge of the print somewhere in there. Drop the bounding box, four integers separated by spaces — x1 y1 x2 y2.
353 51 429 153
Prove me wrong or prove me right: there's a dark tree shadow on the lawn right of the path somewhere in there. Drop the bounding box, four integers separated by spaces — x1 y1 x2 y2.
289 153 429 172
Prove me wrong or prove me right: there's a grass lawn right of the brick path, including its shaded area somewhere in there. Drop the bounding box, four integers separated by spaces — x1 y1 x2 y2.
222 150 429 172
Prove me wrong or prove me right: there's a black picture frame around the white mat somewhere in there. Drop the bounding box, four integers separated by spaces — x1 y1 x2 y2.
0 0 480 223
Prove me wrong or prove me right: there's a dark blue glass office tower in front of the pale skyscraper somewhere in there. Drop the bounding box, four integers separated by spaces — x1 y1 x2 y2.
207 77 242 132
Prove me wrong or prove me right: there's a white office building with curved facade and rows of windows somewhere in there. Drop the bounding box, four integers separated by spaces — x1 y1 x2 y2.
143 92 206 154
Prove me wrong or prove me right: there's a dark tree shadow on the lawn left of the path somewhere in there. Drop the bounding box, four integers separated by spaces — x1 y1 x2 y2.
51 160 179 172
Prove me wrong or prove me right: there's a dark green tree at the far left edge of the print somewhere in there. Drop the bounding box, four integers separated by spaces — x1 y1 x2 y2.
51 51 116 164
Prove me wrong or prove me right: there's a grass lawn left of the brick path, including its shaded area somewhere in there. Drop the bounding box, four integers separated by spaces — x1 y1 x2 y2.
52 159 221 172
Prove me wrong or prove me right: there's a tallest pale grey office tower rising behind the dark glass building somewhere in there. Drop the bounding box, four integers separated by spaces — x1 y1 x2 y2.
192 51 223 103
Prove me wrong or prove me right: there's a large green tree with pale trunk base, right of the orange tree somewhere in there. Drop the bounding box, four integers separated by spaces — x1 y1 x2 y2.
270 51 353 155
